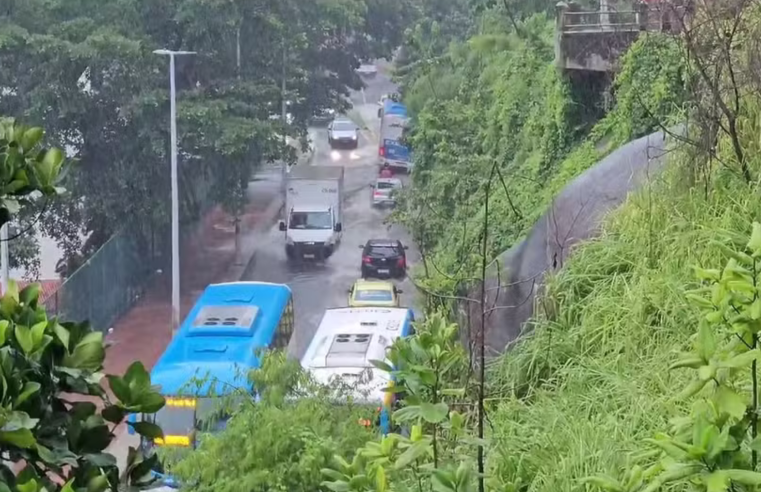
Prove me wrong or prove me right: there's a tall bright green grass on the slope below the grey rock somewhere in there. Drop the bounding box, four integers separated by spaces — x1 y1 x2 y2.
489 150 761 492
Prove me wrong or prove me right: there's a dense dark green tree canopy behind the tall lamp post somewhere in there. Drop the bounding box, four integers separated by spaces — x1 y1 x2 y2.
0 0 416 272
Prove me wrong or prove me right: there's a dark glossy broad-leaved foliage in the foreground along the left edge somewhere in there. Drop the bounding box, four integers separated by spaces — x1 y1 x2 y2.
0 119 164 492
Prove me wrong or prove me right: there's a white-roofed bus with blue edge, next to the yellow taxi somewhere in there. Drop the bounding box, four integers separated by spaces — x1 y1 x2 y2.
301 307 415 435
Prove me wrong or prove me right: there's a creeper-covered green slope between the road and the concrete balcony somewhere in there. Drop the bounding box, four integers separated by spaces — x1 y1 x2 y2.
399 8 685 295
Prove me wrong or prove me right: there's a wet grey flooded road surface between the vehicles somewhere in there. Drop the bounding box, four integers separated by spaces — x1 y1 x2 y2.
243 73 419 357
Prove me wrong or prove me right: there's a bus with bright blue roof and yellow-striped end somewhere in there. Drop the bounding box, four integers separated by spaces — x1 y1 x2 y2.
128 282 294 486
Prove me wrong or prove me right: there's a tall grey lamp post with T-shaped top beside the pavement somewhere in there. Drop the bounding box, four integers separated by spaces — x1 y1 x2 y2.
153 50 195 336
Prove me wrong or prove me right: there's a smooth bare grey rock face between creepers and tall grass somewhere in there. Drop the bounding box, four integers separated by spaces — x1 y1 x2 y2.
459 128 682 356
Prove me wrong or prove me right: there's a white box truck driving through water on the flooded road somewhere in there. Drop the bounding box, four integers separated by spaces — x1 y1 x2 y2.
280 166 344 258
